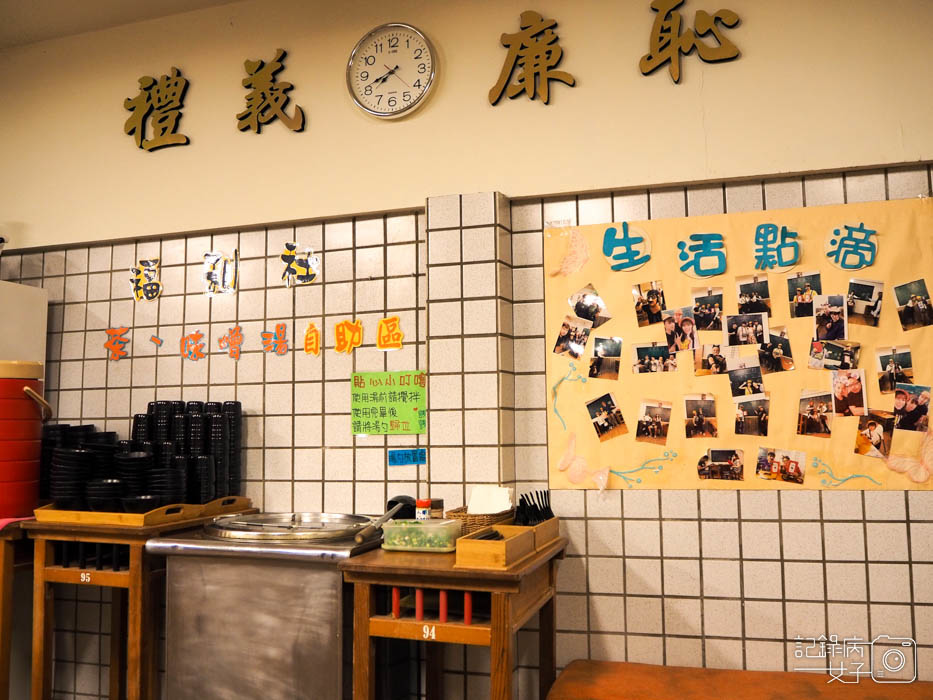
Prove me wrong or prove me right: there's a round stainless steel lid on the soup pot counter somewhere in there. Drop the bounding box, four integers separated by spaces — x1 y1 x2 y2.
204 513 372 542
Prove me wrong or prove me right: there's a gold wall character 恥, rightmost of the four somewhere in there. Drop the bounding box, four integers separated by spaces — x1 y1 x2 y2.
638 0 739 83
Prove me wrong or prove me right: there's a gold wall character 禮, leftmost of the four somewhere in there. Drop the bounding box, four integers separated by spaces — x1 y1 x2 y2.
123 67 188 151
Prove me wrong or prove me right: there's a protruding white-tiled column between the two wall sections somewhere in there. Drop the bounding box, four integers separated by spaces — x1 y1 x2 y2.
427 192 515 508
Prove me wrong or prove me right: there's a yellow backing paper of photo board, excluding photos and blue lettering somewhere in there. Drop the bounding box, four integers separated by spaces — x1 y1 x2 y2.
544 198 933 489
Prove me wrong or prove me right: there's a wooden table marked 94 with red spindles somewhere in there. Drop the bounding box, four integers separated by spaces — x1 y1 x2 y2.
339 538 567 700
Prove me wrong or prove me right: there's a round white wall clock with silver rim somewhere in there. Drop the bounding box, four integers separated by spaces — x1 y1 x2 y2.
347 24 435 118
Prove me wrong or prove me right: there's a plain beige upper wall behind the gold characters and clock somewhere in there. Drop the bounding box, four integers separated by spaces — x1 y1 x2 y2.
0 0 933 248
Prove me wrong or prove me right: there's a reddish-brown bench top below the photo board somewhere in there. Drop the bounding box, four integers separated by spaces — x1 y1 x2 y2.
547 659 933 700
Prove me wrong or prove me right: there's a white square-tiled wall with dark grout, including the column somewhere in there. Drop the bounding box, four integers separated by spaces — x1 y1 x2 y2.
0 164 933 698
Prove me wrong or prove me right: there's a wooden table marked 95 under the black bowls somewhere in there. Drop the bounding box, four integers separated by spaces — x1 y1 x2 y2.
21 509 257 700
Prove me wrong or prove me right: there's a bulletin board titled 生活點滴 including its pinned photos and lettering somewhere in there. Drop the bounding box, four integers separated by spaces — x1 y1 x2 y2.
544 198 933 489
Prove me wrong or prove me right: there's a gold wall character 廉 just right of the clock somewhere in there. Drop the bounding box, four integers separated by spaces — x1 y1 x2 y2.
489 10 576 105
